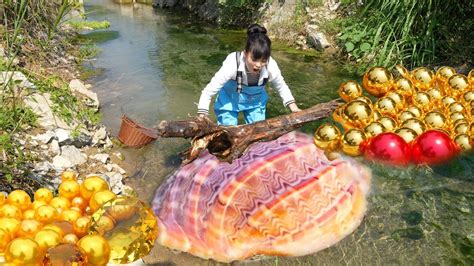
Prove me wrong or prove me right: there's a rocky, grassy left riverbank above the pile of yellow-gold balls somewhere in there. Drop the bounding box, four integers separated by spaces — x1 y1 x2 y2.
0 3 132 195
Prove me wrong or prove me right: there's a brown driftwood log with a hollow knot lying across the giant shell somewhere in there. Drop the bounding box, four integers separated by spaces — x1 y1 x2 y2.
156 100 340 164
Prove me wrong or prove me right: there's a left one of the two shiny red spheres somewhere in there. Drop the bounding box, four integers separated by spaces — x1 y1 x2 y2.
361 132 411 166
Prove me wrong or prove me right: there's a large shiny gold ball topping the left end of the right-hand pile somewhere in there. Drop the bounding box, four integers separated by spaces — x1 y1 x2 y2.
362 67 393 97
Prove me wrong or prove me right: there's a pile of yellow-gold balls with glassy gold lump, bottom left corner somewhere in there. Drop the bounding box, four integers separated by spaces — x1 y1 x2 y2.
0 171 157 265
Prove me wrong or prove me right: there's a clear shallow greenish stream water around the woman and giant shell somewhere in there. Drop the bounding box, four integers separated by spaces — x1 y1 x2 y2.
85 0 474 265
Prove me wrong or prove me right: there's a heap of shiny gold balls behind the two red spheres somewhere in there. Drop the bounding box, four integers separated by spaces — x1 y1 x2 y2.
314 65 474 156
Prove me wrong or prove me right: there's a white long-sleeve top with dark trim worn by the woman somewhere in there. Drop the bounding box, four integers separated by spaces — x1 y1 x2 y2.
198 52 295 114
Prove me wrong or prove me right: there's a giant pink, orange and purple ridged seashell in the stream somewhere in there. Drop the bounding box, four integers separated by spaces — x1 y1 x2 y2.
152 132 370 262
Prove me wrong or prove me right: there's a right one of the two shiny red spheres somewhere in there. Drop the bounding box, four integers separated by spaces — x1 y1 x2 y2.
412 130 459 165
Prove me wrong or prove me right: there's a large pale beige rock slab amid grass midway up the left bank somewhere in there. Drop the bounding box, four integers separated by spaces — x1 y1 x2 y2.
24 93 75 130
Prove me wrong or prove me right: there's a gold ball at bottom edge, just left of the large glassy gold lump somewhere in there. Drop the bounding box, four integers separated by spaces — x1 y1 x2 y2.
77 235 110 265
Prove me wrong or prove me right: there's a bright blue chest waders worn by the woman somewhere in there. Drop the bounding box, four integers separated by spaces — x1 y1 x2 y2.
214 52 268 126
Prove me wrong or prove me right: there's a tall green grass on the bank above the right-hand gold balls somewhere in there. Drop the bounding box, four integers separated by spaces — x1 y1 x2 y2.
336 0 474 73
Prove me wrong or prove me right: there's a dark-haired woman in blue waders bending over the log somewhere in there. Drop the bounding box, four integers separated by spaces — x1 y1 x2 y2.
198 24 300 126
